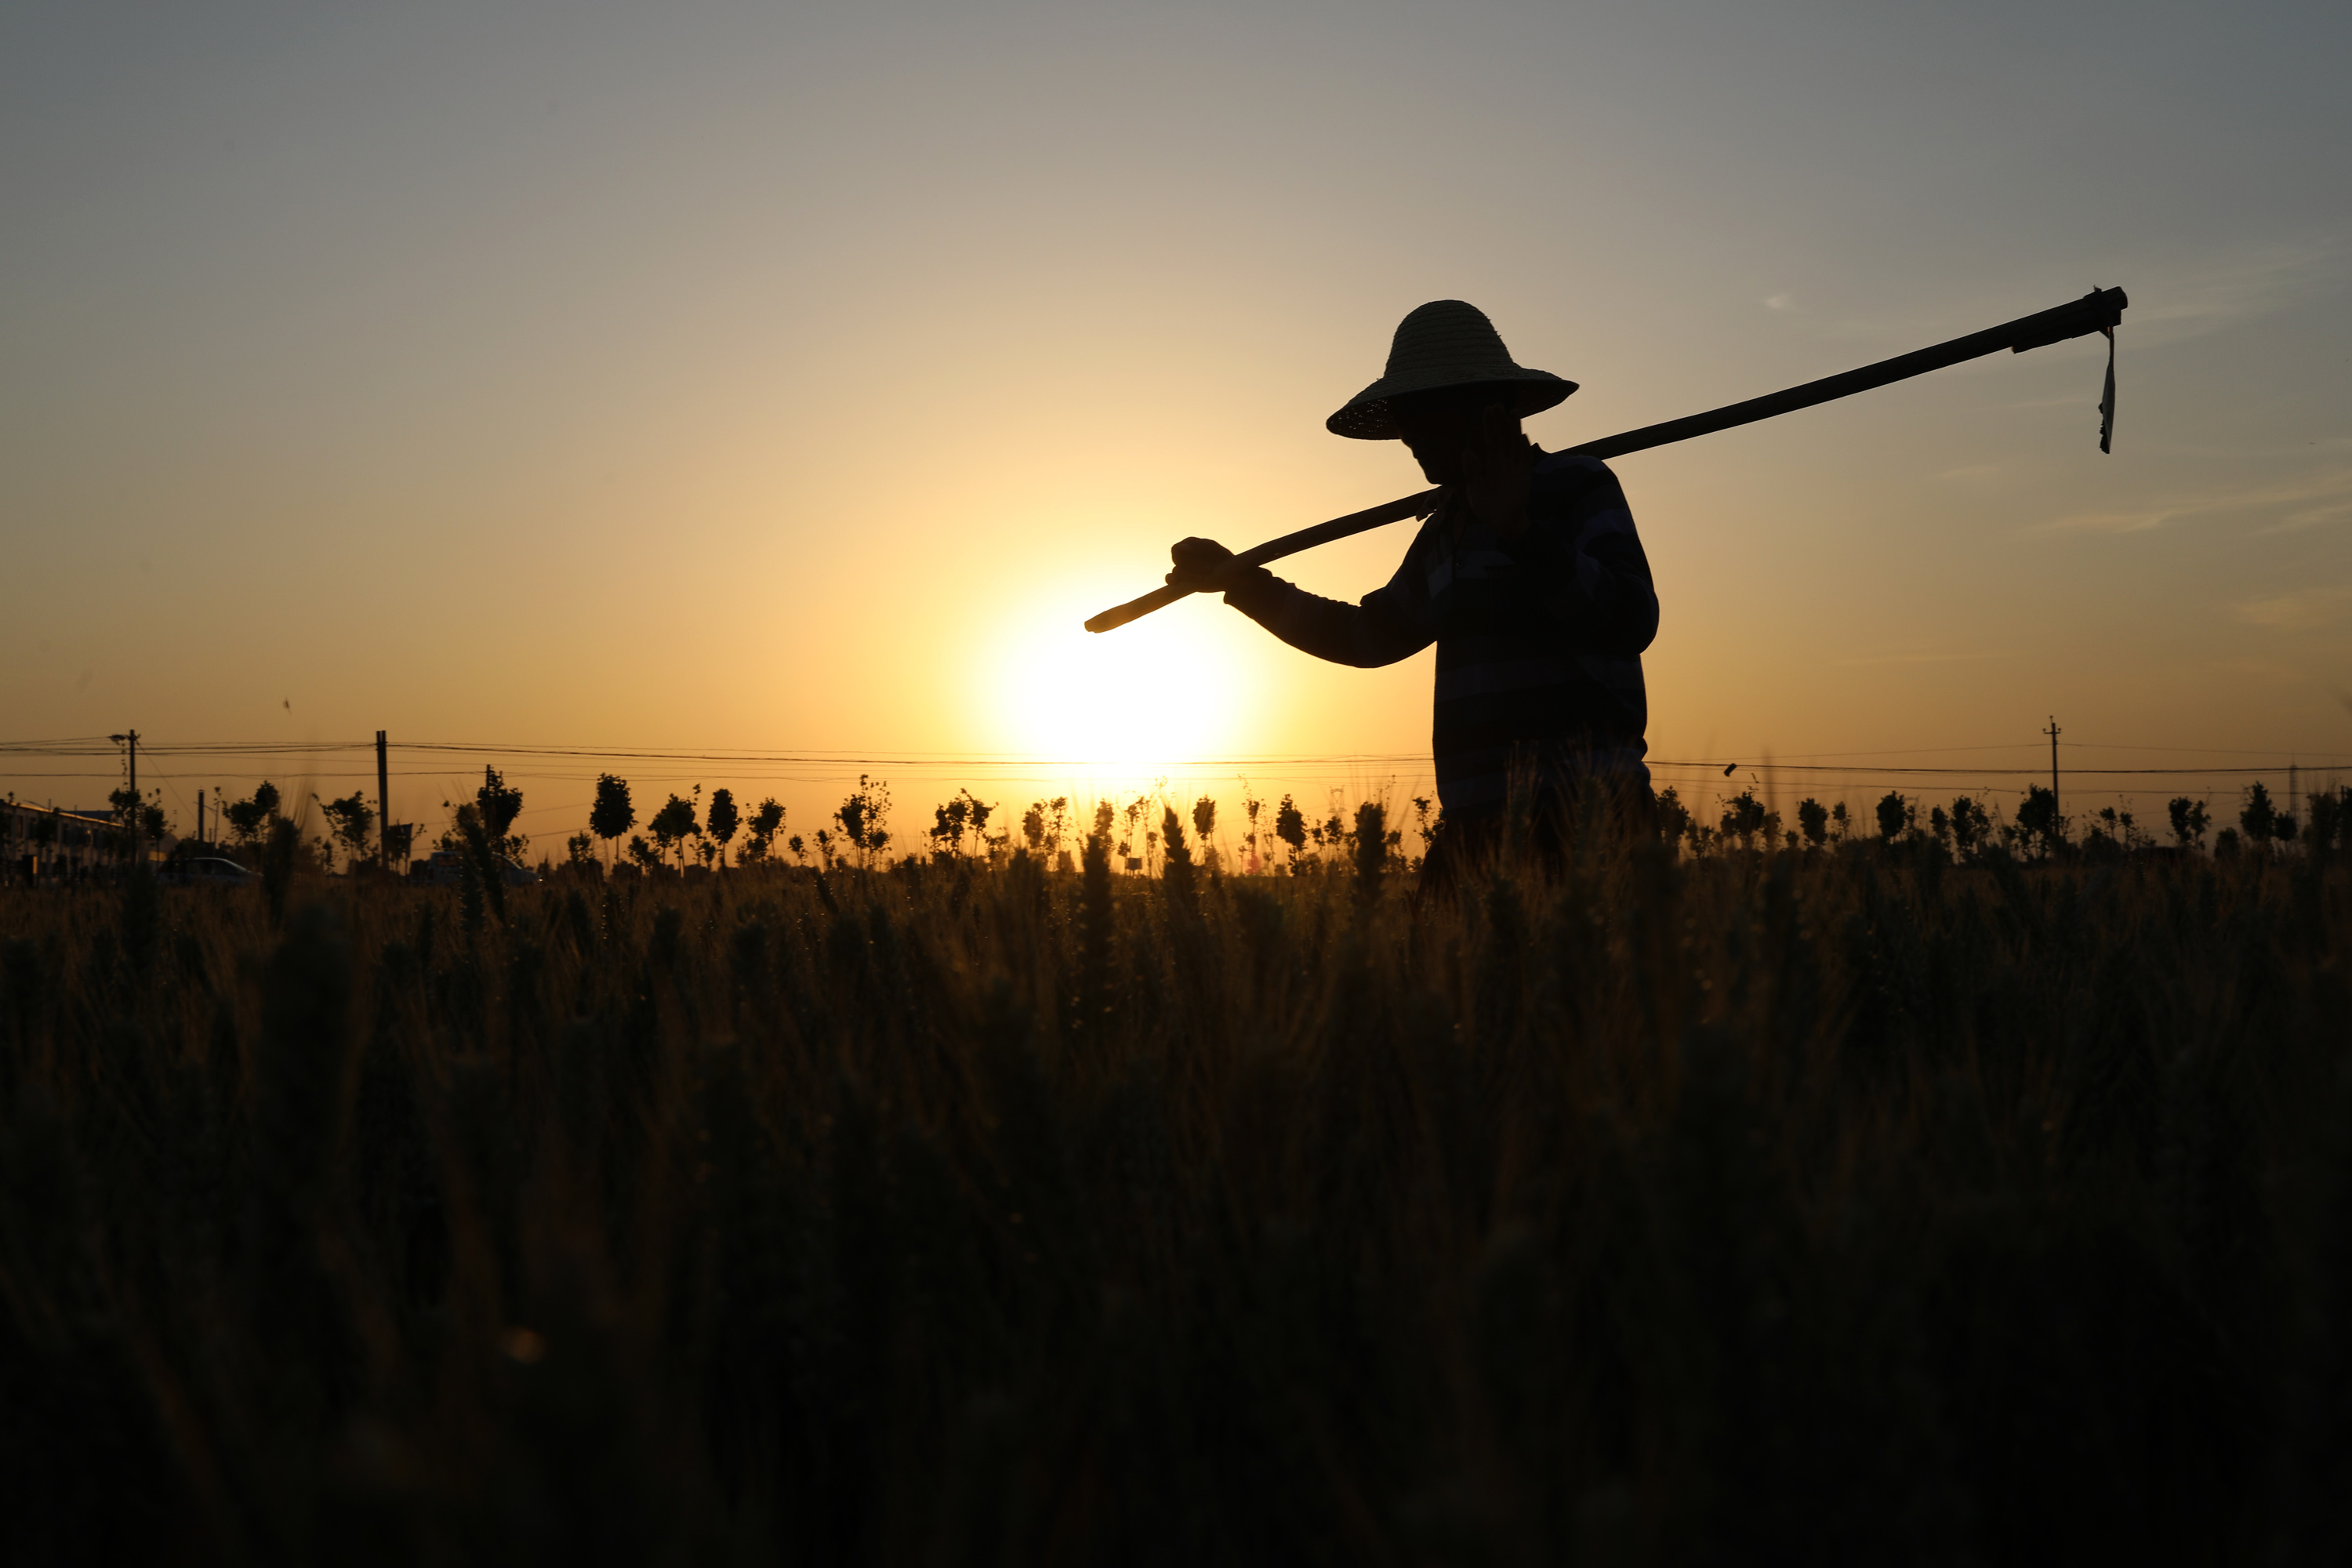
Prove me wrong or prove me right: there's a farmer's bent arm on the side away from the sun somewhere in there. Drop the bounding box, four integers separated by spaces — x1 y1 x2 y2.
1501 454 1658 654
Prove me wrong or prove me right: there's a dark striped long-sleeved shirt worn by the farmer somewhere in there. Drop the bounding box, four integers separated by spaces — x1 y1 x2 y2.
1225 449 1658 813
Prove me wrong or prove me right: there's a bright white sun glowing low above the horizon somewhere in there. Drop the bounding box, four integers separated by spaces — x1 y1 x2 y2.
978 590 1258 776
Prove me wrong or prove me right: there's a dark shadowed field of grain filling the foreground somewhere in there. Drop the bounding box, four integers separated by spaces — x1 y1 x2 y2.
0 834 2352 1563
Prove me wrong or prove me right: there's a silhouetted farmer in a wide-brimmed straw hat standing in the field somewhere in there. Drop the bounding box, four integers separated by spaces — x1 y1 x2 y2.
1167 299 1658 884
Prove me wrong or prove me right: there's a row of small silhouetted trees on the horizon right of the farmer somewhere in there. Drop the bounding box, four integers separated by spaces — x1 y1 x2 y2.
1658 781 2352 860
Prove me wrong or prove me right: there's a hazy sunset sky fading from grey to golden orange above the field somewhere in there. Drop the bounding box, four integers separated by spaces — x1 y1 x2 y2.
0 0 2352 848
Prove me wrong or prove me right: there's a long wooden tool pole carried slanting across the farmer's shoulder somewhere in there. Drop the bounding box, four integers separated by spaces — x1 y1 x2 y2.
1087 289 2131 633
